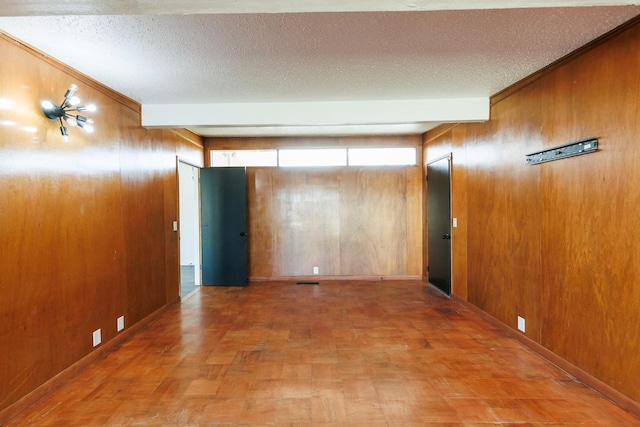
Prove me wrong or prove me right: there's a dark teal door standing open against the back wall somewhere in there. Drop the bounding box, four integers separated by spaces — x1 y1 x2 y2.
200 168 247 286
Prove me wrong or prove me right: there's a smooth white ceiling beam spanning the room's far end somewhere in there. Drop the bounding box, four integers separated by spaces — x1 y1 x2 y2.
142 98 489 135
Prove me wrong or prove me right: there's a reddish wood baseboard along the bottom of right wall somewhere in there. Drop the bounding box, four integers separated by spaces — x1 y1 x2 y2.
451 295 640 417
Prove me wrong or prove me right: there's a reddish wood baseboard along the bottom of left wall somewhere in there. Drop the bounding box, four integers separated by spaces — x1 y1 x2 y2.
0 298 180 425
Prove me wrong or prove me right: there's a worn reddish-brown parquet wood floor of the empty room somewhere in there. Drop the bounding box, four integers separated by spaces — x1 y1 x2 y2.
9 282 640 427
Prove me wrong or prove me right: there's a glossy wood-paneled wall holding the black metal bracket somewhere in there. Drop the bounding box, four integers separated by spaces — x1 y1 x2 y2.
425 19 640 408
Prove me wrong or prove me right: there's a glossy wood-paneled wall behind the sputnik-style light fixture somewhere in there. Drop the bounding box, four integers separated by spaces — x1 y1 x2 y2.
0 34 203 411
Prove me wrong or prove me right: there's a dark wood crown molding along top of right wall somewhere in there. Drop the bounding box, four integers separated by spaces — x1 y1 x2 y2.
489 15 640 107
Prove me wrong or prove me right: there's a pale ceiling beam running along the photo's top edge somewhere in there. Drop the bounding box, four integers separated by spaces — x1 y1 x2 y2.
0 0 640 16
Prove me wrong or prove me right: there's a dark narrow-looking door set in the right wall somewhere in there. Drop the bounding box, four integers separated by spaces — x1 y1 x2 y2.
427 157 451 295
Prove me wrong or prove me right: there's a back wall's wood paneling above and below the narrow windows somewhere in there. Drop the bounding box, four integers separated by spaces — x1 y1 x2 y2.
205 137 422 279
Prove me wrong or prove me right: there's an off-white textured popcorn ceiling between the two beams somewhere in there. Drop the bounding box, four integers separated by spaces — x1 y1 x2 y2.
0 1 640 135
